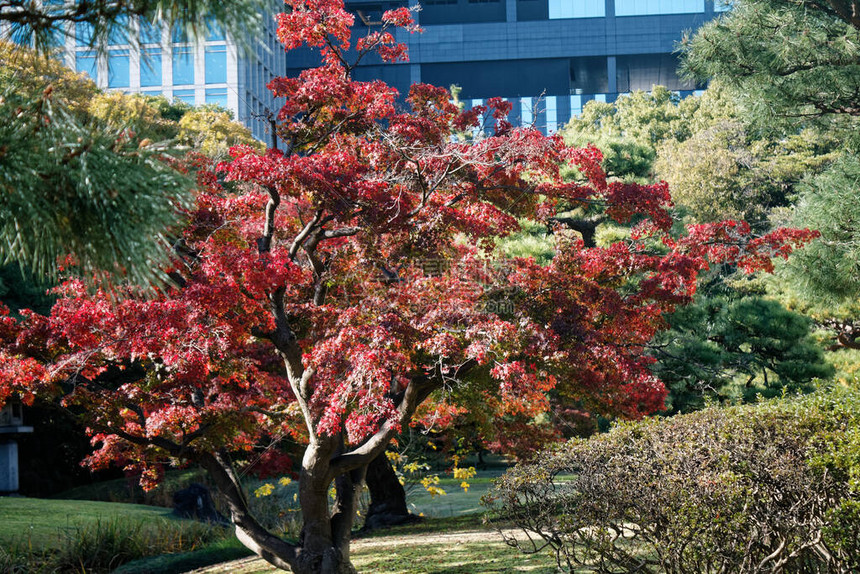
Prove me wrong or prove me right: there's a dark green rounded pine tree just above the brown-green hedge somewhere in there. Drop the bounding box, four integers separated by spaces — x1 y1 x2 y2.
653 294 834 412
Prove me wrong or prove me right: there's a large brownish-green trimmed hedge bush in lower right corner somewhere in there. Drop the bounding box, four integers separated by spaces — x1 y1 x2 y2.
487 389 860 573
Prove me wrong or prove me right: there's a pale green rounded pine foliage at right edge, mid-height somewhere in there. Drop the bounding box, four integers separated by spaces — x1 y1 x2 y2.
780 154 860 312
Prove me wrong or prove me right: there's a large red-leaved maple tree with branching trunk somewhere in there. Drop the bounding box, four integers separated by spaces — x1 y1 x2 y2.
0 0 814 573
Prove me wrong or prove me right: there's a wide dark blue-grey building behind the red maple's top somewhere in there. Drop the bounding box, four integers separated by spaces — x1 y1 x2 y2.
288 0 725 132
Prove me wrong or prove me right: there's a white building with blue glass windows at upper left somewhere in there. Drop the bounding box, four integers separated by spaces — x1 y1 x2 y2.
1 6 286 143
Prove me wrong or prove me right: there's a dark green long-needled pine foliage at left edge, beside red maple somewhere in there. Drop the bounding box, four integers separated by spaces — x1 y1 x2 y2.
0 84 190 284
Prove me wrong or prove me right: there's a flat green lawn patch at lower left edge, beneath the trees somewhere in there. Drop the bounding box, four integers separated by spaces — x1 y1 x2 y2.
0 497 170 548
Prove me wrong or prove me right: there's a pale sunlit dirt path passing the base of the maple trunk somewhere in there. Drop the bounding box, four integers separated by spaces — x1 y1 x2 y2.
186 530 522 574
